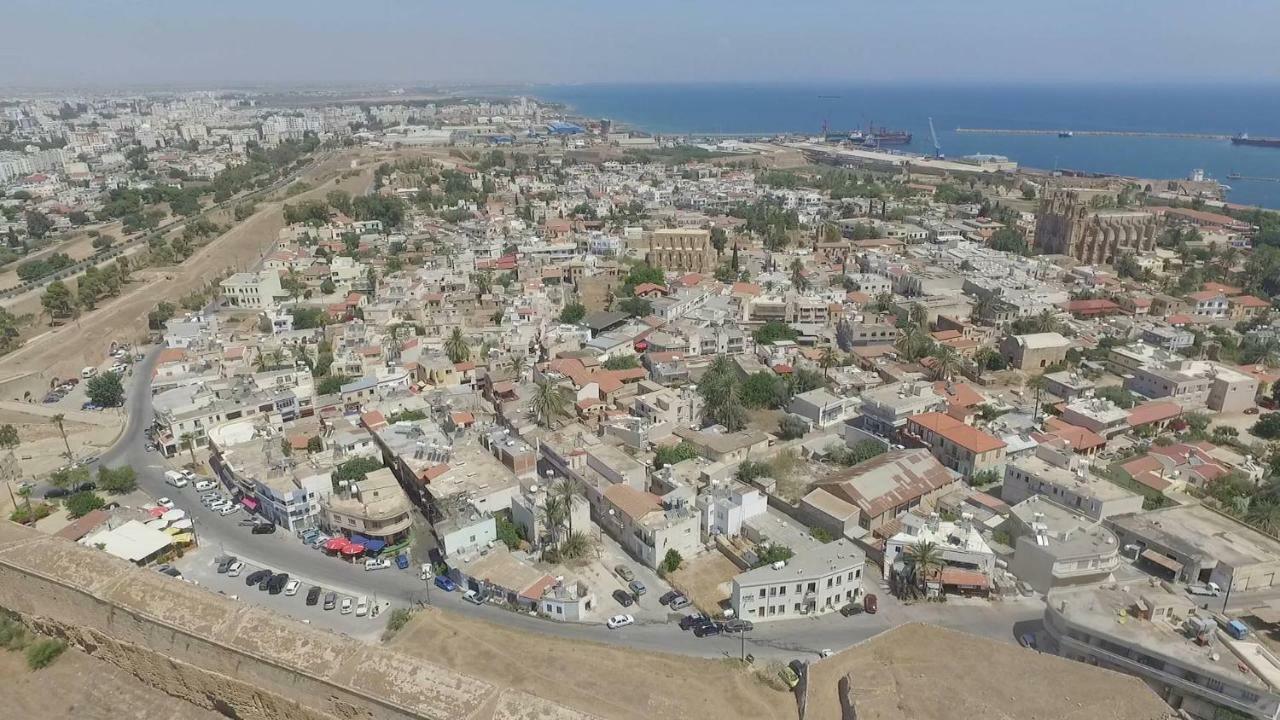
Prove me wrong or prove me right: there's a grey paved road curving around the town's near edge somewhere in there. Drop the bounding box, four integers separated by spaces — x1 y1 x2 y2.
101 350 1043 659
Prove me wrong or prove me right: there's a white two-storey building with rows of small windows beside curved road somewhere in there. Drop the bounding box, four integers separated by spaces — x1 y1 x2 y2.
730 539 867 623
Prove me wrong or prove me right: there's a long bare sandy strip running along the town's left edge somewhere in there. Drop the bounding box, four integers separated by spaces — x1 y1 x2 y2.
0 152 372 396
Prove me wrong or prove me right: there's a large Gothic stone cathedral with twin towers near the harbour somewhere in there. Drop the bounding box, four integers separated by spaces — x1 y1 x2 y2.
1036 190 1160 265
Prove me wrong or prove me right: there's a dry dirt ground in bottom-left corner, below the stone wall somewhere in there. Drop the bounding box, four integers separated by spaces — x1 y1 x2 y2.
0 650 221 720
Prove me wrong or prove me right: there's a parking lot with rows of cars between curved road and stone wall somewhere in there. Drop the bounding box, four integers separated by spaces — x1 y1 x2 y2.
173 540 394 641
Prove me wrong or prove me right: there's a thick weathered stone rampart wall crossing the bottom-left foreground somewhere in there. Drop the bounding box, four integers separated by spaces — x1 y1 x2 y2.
0 523 588 720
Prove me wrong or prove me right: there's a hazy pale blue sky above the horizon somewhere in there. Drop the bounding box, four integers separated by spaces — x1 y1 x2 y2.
0 0 1280 87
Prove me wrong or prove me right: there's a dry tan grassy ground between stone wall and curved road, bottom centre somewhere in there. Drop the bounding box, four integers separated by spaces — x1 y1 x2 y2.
392 609 796 720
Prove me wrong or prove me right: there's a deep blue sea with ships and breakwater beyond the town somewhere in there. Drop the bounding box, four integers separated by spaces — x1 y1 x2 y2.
532 85 1280 209
